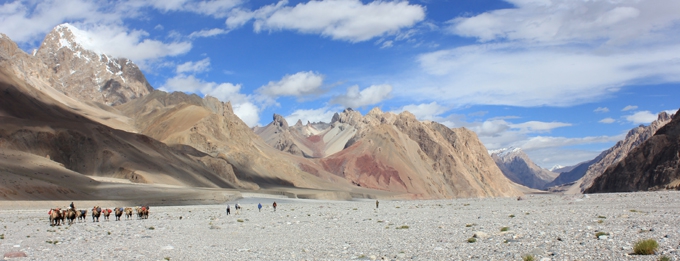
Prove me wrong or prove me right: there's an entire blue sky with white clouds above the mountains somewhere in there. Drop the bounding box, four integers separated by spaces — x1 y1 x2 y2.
0 0 680 168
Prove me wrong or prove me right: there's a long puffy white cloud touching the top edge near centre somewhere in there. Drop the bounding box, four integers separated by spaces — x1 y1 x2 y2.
227 0 425 42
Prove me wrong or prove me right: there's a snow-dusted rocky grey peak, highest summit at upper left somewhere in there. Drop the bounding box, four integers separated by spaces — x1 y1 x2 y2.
35 24 153 105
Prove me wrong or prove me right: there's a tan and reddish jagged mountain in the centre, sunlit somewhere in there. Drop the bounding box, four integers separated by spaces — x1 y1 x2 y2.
256 108 520 198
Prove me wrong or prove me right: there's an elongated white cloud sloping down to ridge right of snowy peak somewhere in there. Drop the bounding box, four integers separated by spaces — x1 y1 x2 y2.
159 74 260 127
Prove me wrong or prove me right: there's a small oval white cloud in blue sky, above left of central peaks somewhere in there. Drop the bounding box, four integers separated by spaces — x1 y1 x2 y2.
257 71 324 97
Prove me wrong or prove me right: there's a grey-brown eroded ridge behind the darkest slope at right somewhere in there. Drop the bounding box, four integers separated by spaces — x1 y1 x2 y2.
576 112 677 192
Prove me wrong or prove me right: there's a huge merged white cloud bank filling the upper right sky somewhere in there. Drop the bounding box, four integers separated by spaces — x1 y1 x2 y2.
404 0 680 107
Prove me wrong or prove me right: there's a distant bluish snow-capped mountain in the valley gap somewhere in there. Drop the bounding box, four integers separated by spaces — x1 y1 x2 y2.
489 148 558 189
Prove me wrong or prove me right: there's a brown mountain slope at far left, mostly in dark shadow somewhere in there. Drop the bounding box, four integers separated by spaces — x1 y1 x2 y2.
0 35 248 199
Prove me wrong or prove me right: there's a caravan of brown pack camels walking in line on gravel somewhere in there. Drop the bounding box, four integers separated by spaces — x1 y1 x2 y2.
47 203 149 226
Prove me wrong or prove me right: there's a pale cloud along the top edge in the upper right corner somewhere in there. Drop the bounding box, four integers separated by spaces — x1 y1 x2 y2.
448 0 680 44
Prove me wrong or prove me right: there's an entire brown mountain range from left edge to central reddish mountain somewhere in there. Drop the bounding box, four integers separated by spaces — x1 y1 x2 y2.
0 24 522 199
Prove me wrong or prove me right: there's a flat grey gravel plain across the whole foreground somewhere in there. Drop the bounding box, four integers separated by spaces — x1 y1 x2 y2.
0 192 680 260
